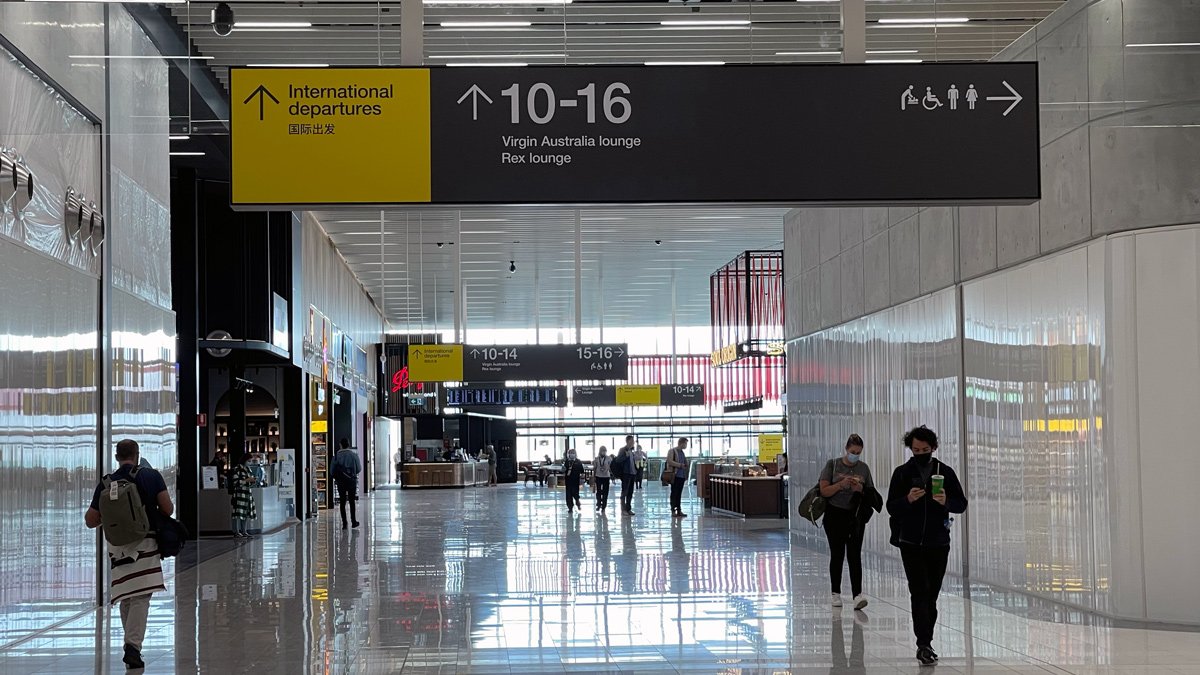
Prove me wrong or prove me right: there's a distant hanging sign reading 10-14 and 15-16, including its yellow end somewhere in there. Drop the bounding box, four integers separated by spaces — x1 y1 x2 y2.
408 345 629 382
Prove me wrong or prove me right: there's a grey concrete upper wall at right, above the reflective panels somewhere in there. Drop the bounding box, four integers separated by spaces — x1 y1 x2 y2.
785 0 1200 336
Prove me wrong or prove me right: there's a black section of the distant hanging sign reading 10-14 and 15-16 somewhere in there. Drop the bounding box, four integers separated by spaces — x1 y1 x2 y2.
462 345 629 382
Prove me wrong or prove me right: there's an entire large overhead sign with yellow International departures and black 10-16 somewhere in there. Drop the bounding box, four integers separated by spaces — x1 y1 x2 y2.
230 62 1040 208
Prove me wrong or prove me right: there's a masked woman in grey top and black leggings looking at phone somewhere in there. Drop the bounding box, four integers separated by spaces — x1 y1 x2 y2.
821 434 875 609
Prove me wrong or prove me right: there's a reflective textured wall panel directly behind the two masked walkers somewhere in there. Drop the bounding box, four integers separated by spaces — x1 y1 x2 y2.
787 291 965 568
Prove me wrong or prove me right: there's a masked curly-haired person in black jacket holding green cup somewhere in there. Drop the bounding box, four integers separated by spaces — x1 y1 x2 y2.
888 426 967 665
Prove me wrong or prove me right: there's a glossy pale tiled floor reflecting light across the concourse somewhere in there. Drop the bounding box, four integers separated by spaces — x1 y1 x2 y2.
7 485 1200 675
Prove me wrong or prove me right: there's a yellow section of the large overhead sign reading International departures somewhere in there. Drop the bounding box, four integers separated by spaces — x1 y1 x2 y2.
229 68 431 205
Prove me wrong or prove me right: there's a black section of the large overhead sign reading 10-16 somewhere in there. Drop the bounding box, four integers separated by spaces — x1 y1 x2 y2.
431 62 1040 203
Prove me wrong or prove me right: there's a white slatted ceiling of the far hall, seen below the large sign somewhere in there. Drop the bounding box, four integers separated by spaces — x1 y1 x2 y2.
314 207 787 329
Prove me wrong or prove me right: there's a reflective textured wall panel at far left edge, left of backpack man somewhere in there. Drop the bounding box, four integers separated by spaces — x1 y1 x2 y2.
0 239 98 646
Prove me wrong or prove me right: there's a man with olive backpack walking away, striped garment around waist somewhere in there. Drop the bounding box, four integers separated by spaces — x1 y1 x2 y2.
84 438 175 669
